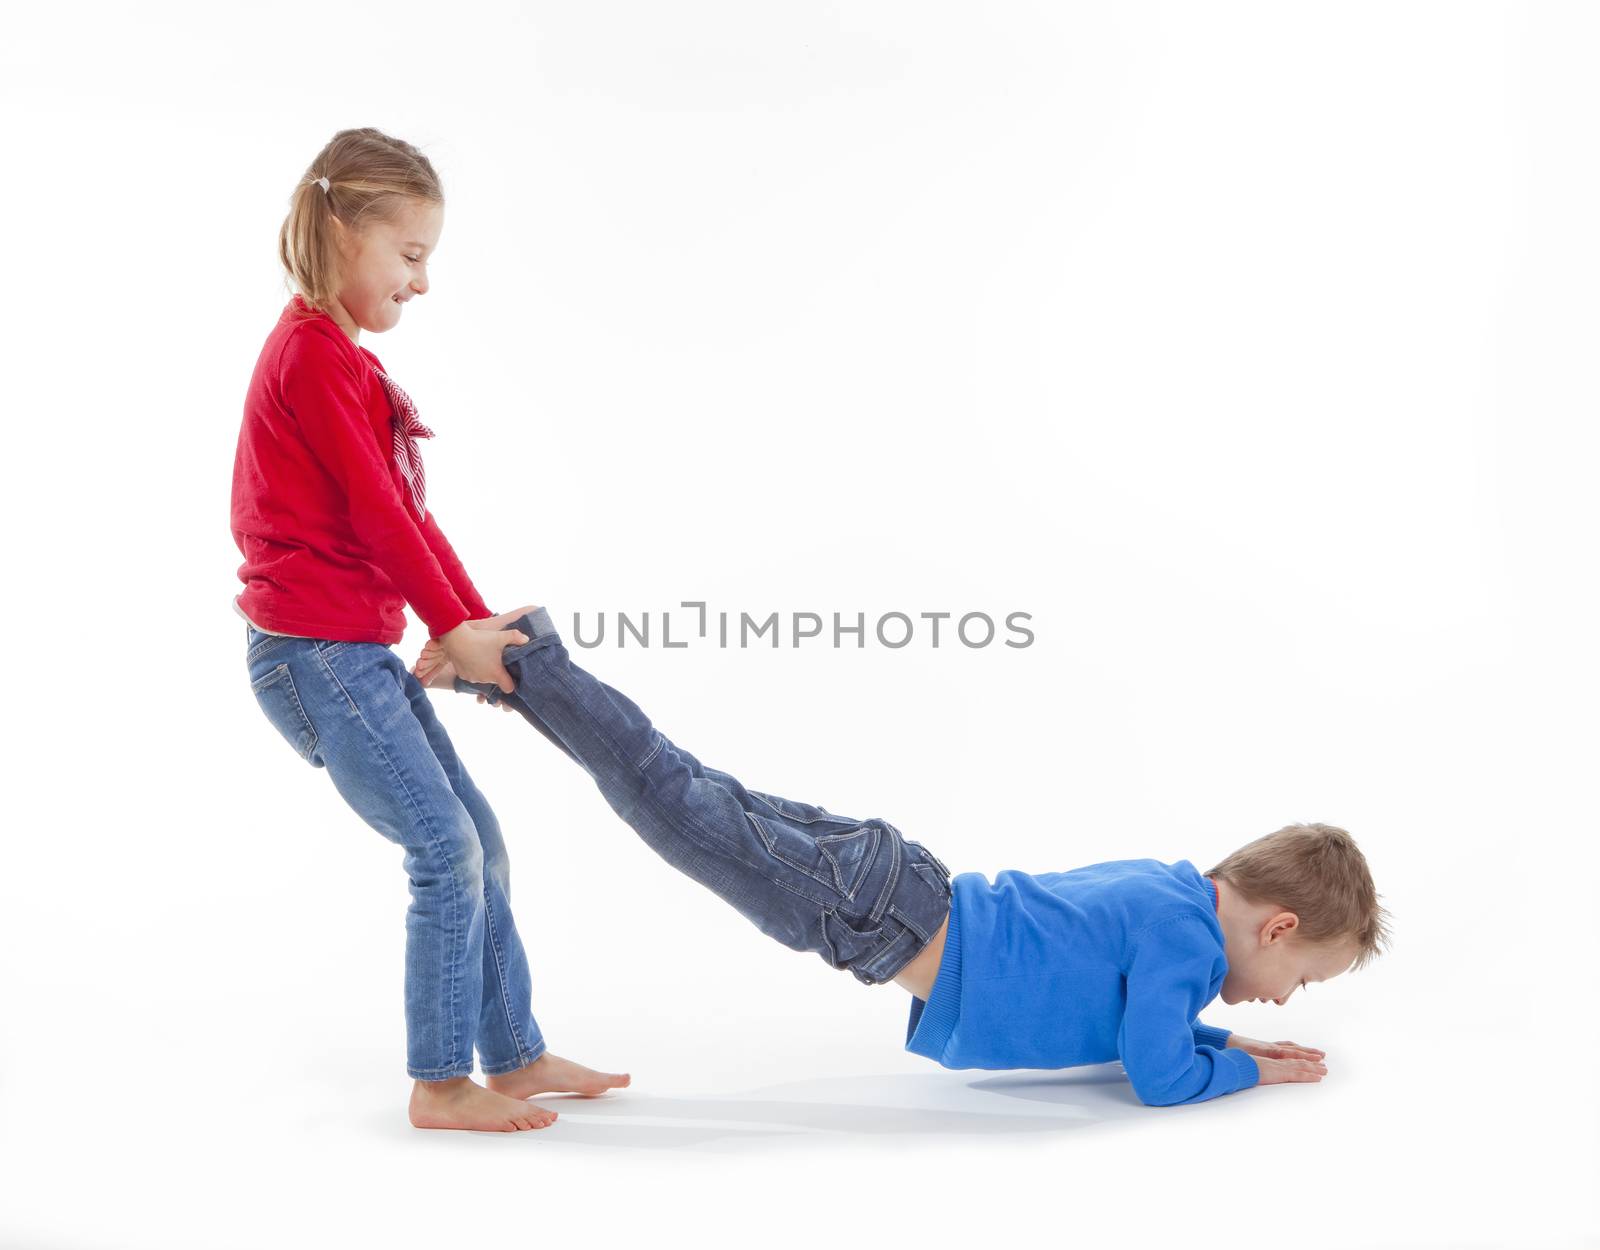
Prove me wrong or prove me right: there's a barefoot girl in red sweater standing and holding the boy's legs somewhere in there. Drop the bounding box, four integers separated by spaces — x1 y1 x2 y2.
230 128 629 1132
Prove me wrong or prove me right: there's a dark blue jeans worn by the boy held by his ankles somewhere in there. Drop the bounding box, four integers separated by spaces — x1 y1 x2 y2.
454 608 950 984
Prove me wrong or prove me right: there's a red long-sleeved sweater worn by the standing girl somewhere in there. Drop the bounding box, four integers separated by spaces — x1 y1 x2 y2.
232 294 493 645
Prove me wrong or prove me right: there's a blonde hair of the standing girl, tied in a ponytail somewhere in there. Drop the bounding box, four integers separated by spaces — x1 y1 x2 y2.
278 126 445 312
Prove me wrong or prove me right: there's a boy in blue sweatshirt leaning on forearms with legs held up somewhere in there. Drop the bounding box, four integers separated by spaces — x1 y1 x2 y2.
413 608 1387 1106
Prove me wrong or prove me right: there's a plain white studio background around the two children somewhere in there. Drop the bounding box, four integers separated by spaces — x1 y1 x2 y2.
0 0 1600 1250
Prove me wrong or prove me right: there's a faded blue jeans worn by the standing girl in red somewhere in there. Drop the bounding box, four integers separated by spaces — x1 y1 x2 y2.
245 626 544 1080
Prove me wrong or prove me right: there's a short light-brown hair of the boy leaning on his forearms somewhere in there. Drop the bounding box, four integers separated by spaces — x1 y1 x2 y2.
1205 824 1389 972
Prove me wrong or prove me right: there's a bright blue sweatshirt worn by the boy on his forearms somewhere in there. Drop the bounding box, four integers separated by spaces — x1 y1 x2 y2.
906 859 1261 1106
